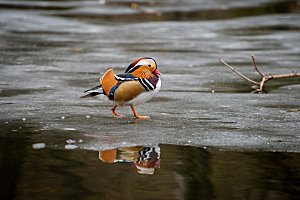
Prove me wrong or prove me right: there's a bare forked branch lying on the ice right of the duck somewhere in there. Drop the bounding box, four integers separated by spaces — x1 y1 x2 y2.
219 55 300 93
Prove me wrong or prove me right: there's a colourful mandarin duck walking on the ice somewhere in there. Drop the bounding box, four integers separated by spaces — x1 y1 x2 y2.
81 57 161 119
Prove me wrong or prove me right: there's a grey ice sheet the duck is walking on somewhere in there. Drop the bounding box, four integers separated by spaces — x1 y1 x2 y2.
0 0 300 152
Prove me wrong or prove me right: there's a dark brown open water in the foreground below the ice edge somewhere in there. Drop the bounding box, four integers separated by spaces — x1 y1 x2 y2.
1 138 300 200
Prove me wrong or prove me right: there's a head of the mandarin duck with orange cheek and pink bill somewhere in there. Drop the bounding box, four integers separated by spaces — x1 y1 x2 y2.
125 57 161 78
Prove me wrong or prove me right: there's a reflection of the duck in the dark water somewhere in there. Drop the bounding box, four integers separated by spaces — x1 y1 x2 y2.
99 146 160 175
